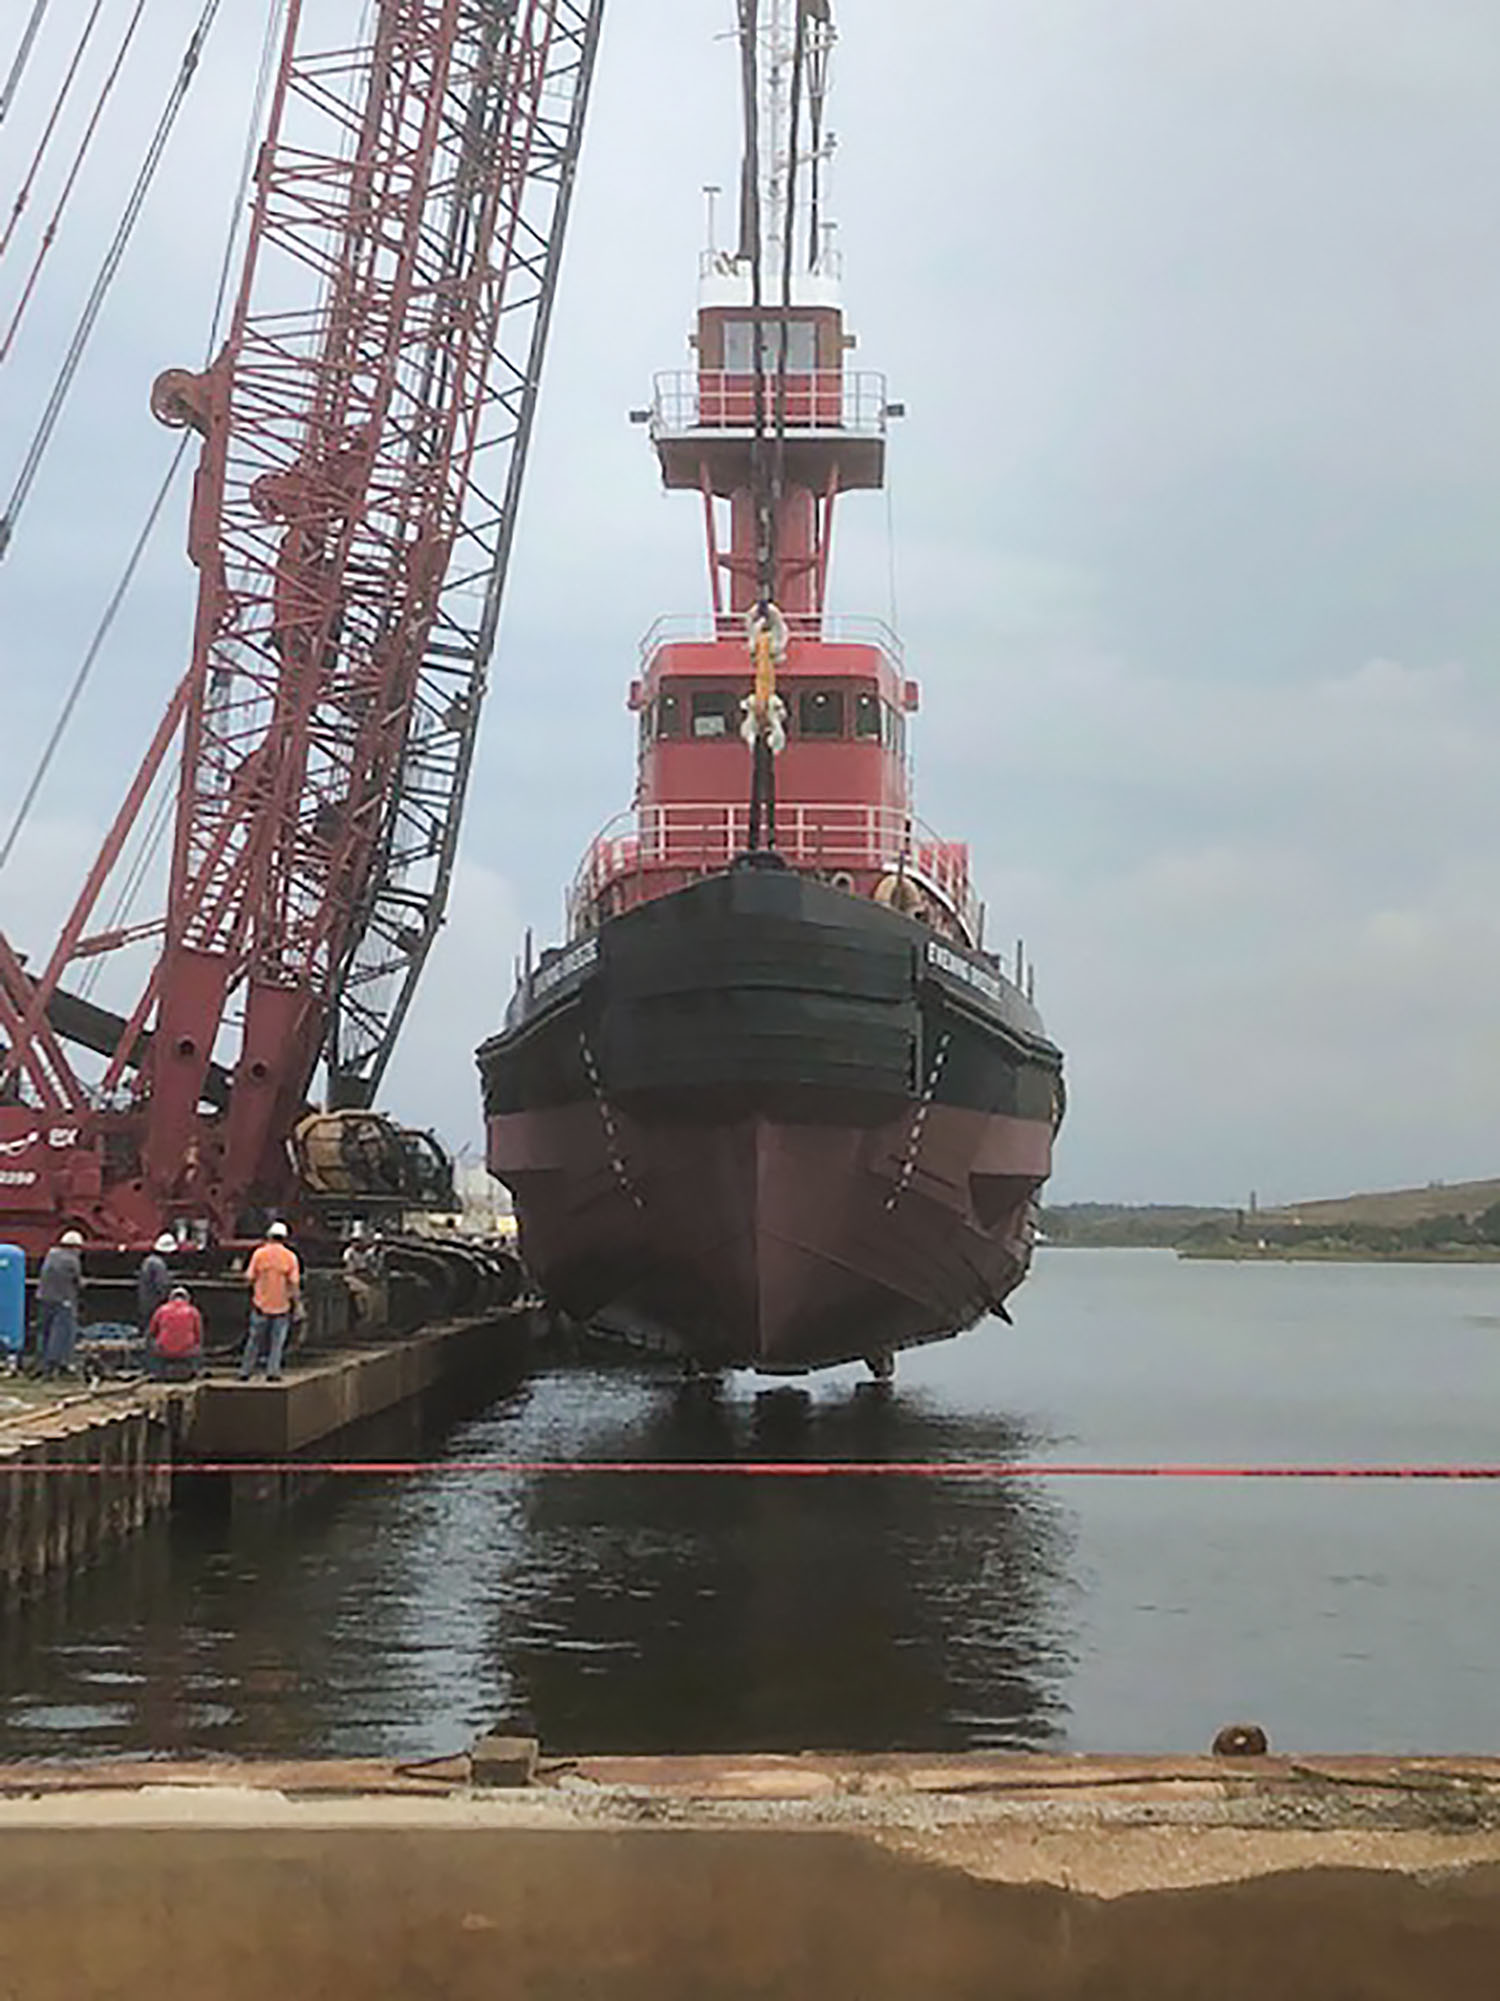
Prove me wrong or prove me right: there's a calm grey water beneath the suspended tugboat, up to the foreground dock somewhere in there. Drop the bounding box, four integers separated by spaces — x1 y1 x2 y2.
0 1251 1500 1757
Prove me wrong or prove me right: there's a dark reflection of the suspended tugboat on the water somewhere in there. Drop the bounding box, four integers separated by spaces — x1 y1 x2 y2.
506 1387 1070 1751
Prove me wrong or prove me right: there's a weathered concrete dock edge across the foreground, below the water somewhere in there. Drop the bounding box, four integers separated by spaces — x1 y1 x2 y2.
0 1755 1500 2001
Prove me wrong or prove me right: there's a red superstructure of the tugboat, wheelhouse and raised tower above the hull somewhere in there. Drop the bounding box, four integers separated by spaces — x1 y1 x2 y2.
570 278 982 944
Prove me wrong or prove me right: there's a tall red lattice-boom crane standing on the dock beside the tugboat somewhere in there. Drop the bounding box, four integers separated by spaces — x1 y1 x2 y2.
0 0 604 1251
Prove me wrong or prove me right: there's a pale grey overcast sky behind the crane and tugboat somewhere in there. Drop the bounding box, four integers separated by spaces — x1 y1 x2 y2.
0 0 1500 1201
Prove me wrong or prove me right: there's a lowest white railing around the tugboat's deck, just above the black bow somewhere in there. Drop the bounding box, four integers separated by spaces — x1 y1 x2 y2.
568 800 982 942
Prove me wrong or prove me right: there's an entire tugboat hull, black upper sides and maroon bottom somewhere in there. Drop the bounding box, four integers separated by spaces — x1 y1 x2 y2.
478 868 1062 1371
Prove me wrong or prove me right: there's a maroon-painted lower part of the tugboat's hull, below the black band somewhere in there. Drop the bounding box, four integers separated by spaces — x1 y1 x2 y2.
490 1103 1052 1373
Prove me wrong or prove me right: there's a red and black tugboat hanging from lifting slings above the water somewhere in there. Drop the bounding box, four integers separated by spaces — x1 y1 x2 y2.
478 0 1064 1377
